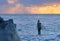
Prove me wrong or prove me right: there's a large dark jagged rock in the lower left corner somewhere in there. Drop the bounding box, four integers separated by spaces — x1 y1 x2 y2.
0 17 20 41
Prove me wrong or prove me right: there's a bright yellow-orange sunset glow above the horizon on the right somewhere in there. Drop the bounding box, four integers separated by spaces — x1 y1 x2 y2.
28 4 60 14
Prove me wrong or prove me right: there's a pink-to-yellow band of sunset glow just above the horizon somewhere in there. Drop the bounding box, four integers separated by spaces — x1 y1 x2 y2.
8 4 60 14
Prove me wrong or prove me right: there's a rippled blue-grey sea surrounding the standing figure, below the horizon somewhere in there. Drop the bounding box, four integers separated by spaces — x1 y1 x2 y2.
0 14 60 41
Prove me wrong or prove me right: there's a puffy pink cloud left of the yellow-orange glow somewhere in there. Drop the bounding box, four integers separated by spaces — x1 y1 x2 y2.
8 4 24 13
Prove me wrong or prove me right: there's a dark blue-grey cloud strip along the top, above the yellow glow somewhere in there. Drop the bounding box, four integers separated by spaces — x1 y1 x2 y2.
18 0 60 5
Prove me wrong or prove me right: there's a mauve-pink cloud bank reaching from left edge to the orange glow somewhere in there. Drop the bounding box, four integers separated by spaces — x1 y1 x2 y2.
0 4 24 14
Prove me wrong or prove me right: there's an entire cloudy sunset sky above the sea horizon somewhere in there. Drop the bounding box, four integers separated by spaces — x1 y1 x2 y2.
0 0 60 14
